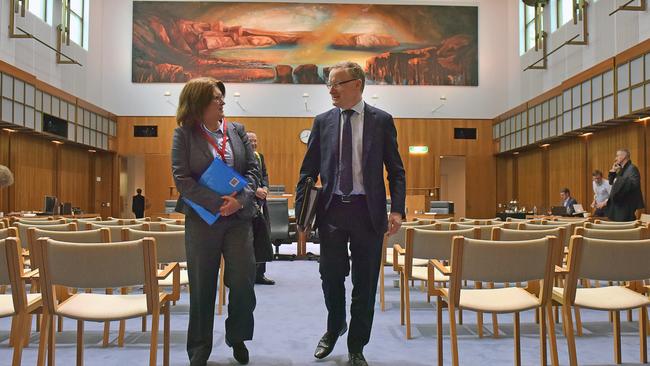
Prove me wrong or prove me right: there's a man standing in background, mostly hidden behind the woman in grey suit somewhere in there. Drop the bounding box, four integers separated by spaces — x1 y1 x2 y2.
246 131 275 285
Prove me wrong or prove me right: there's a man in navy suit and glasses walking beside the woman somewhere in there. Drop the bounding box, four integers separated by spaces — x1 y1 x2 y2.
296 62 406 365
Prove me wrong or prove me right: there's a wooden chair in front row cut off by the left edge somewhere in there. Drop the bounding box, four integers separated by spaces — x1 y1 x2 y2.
0 237 43 366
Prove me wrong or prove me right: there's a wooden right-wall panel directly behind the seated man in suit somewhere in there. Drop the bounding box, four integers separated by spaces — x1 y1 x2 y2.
538 138 591 209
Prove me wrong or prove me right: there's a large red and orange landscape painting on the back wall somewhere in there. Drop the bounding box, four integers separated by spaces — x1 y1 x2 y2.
132 1 478 86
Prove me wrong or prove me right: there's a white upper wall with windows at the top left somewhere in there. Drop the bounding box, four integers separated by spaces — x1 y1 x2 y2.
0 0 103 106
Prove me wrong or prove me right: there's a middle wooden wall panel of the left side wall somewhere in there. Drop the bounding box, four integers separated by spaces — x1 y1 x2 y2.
58 145 92 212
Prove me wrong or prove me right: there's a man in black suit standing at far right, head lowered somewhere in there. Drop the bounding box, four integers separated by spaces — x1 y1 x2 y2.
607 149 645 221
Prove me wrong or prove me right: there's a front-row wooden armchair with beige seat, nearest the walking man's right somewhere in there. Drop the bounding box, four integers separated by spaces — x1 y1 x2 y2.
429 237 559 366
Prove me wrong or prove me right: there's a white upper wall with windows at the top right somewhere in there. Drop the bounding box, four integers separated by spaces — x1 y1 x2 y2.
504 0 650 112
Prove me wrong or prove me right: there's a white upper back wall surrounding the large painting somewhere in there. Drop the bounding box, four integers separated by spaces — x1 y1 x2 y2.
97 0 509 118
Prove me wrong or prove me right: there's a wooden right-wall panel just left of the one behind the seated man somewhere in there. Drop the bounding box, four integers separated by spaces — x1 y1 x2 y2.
515 149 544 209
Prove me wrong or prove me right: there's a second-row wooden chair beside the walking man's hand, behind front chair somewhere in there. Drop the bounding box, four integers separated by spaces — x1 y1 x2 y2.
393 226 480 339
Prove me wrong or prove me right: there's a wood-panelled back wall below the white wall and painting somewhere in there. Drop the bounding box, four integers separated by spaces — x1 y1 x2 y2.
118 117 496 217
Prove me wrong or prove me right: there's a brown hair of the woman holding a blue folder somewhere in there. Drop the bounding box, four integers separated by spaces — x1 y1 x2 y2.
176 77 226 127
